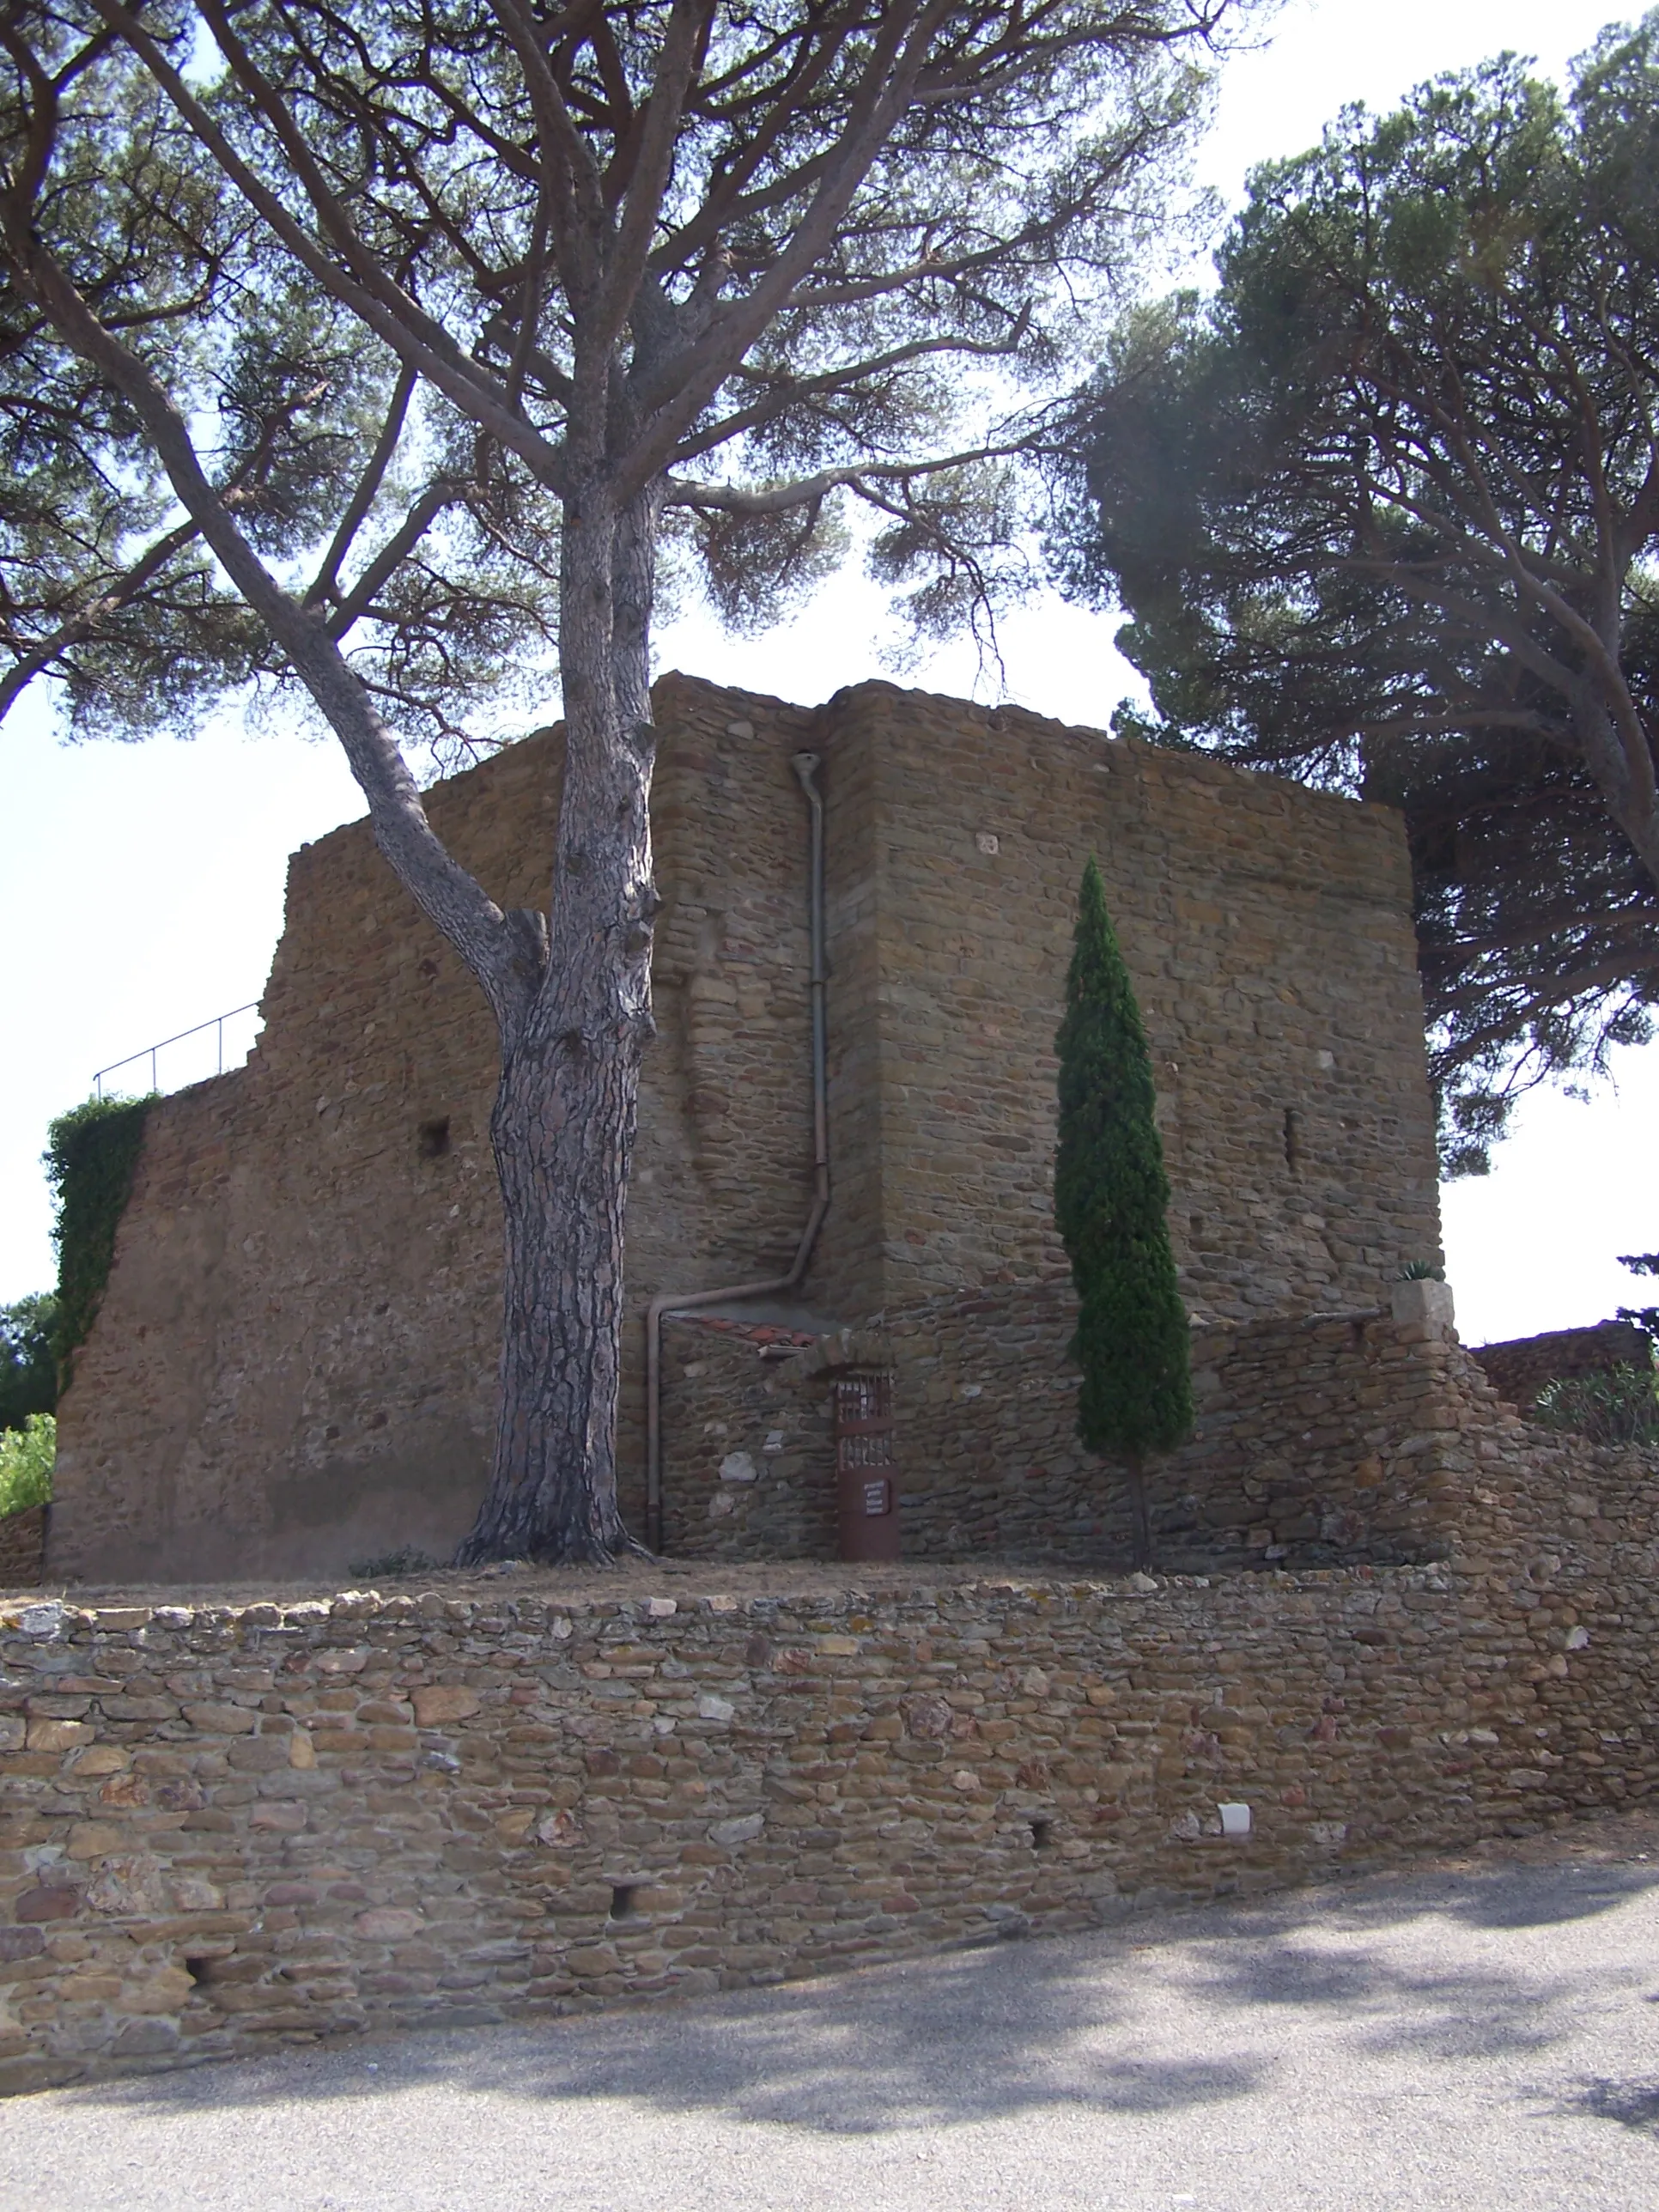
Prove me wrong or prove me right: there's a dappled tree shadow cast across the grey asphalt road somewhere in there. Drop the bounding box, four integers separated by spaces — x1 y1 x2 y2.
45 1865 1659 2135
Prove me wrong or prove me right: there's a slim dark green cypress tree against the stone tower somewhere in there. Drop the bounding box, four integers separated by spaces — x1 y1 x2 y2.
1055 858 1192 1568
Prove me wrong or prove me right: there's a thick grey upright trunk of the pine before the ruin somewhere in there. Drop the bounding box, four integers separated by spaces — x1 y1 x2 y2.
458 475 659 1566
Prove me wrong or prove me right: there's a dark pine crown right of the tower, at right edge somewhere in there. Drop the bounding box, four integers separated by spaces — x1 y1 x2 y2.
1051 30 1659 1175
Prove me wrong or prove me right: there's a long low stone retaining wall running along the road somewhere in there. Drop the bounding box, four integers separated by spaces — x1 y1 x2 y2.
0 1409 1659 2088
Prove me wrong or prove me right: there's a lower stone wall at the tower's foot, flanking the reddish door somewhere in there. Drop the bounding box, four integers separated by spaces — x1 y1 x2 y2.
664 1283 1498 1573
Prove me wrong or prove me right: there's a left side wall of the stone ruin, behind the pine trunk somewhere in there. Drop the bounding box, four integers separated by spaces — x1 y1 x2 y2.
53 679 827 1575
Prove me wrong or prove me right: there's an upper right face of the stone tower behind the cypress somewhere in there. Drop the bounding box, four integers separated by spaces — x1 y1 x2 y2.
827 684 1440 1321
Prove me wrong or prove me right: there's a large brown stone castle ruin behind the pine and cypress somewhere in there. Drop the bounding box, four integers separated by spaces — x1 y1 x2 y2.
49 677 1460 1579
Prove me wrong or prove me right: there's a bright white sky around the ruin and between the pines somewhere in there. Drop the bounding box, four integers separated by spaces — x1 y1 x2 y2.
0 0 1659 1343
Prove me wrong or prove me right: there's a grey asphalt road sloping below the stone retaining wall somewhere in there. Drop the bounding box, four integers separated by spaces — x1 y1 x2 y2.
0 1860 1659 2212
